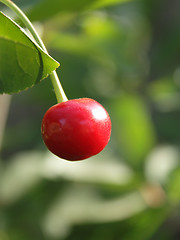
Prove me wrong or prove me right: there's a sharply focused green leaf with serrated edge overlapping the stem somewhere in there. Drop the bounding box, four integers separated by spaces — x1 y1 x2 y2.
0 12 59 94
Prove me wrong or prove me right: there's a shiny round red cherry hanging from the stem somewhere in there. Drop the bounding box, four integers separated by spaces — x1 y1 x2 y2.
41 98 111 161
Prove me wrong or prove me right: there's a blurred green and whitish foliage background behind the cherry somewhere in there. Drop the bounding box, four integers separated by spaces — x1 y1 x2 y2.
0 0 180 240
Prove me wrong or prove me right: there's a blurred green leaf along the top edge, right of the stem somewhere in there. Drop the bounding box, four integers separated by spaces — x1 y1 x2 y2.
28 0 131 21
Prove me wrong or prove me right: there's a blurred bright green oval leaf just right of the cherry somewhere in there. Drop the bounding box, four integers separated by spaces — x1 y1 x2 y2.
112 94 156 167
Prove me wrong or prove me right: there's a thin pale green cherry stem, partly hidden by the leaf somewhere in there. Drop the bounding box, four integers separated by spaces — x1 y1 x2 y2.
0 0 68 103
